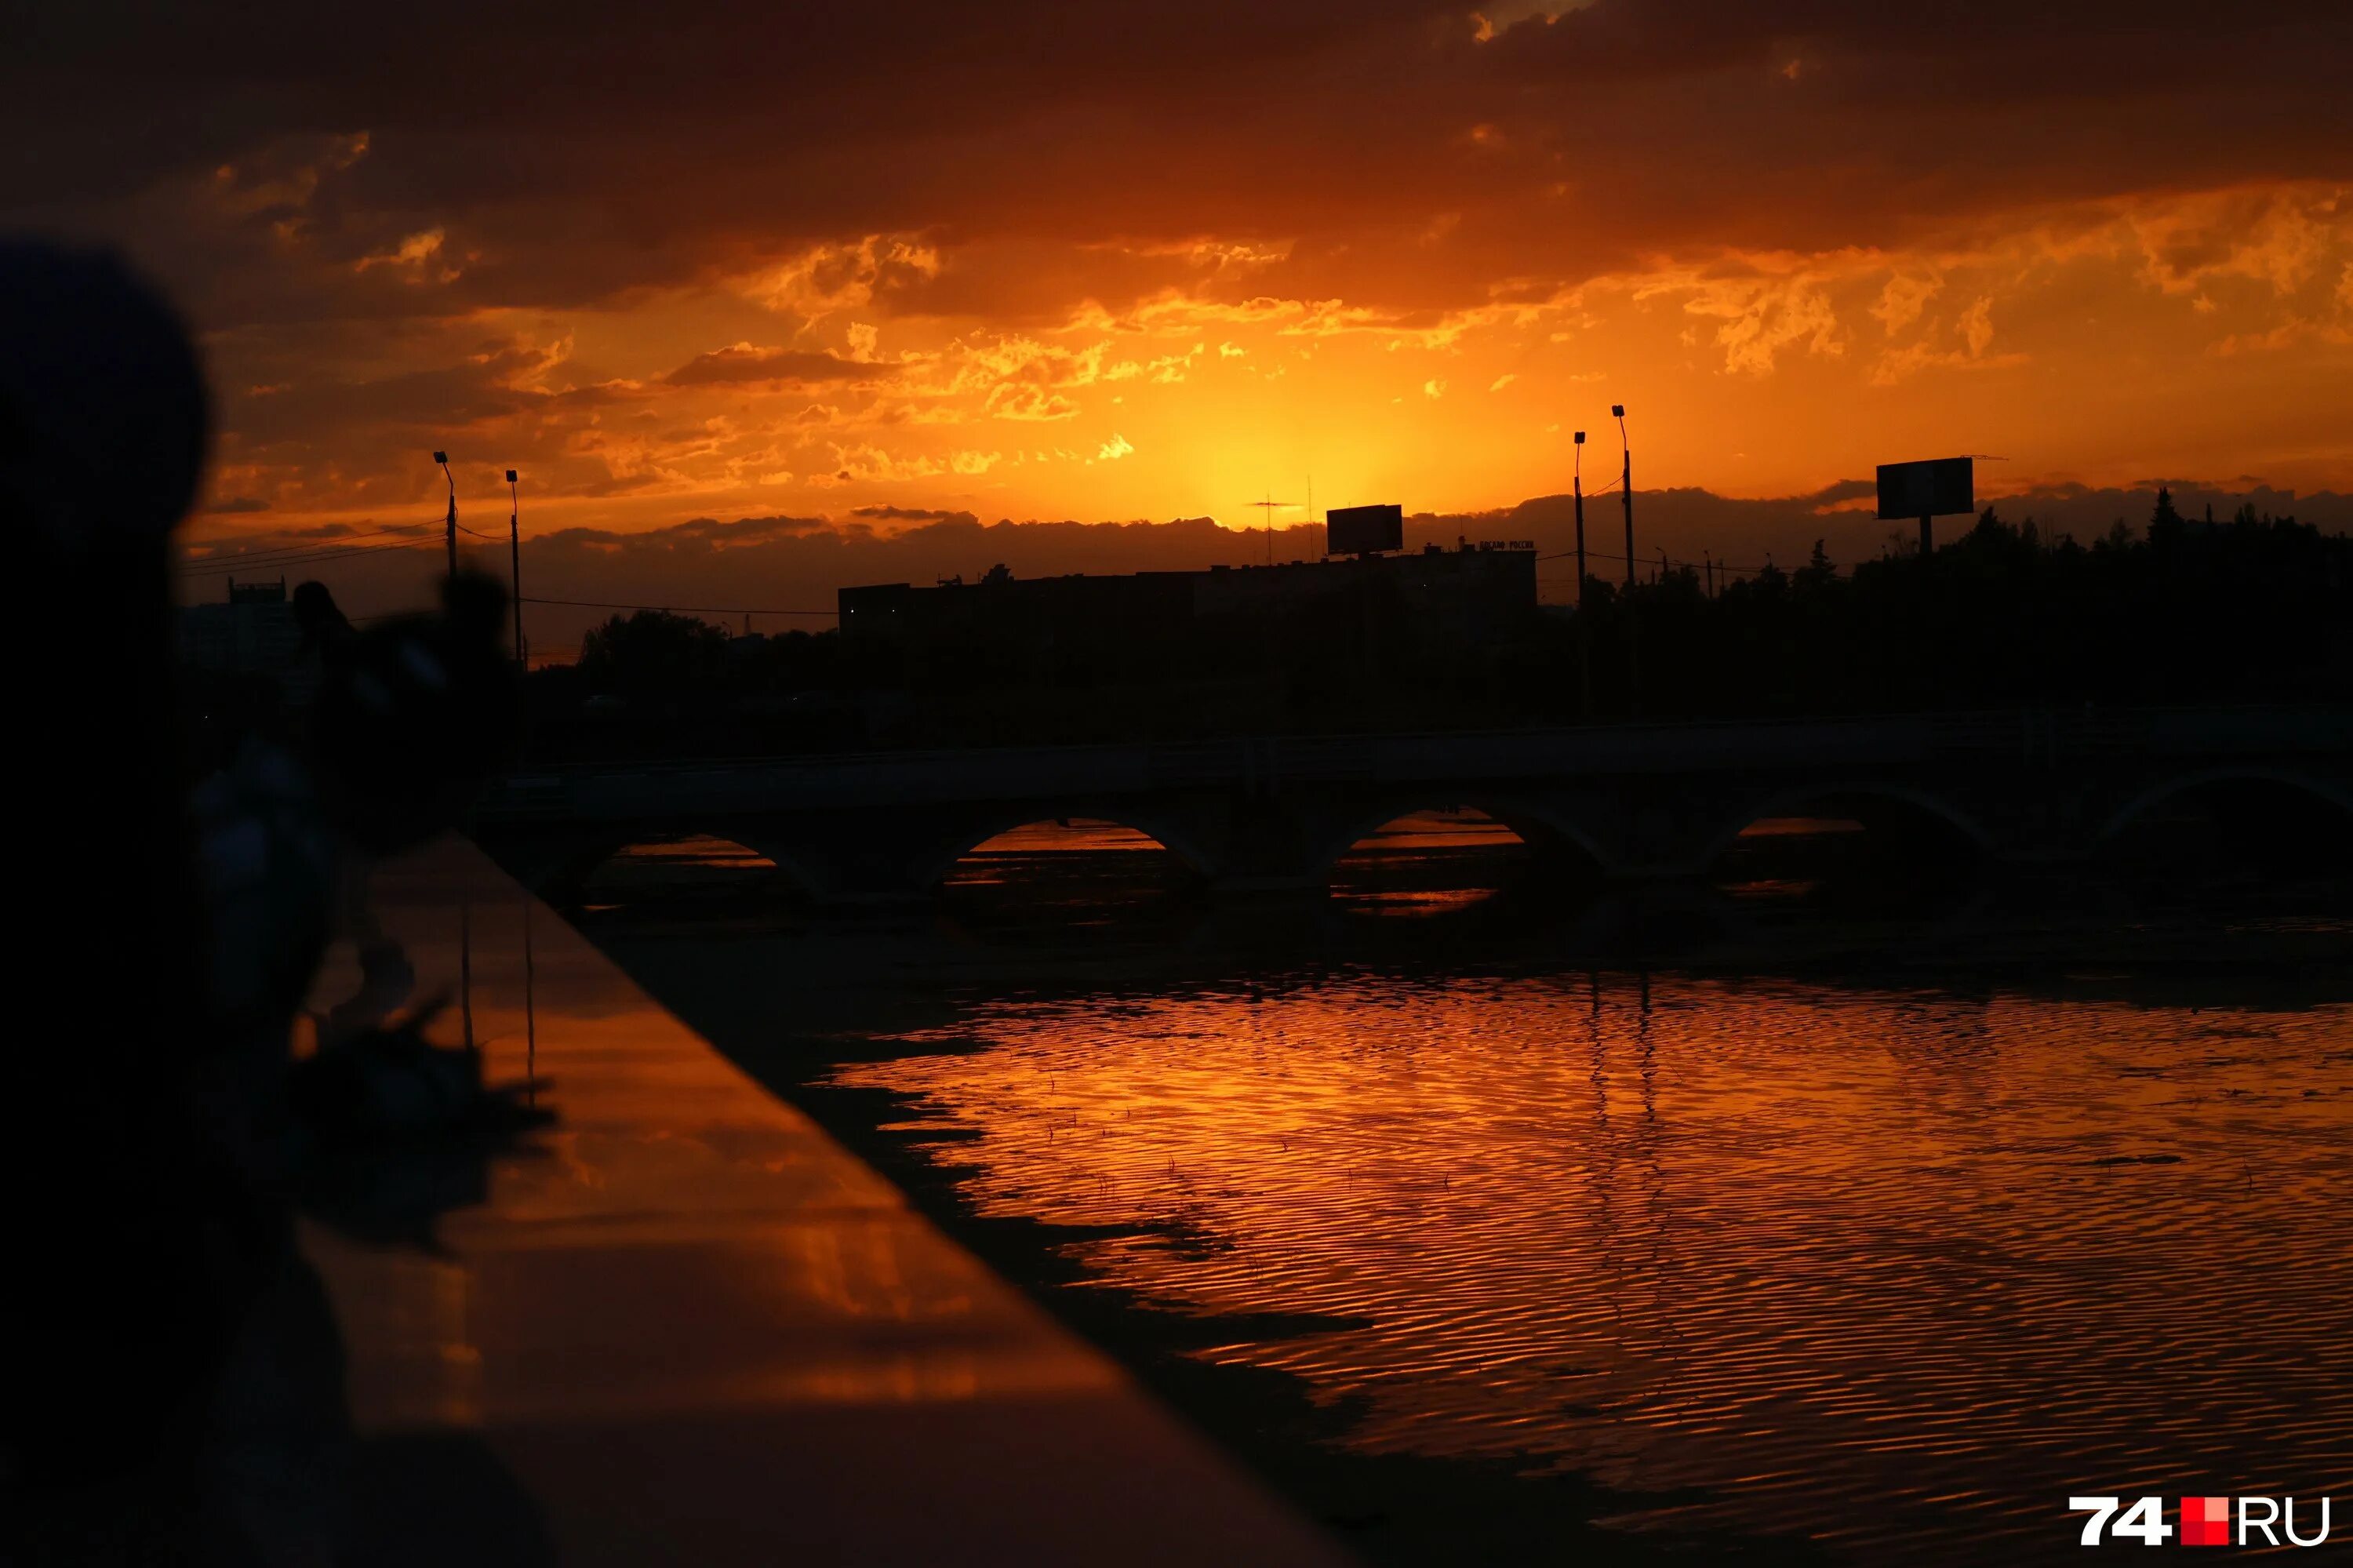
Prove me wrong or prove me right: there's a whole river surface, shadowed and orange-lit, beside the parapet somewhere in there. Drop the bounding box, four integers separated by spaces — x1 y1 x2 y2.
591 822 2353 1563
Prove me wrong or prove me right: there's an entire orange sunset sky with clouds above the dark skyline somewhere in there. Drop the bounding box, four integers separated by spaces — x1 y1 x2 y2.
13 0 2353 631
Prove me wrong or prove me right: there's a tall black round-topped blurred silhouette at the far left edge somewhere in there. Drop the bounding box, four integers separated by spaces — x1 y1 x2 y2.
0 242 222 1535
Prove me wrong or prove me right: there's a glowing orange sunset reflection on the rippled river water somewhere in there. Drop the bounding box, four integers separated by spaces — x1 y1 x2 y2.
833 970 2353 1561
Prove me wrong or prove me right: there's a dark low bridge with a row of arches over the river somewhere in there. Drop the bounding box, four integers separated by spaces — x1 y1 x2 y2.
473 708 2353 904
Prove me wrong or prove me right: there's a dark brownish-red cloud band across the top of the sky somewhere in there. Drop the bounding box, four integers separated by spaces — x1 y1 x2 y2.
0 0 2353 325
